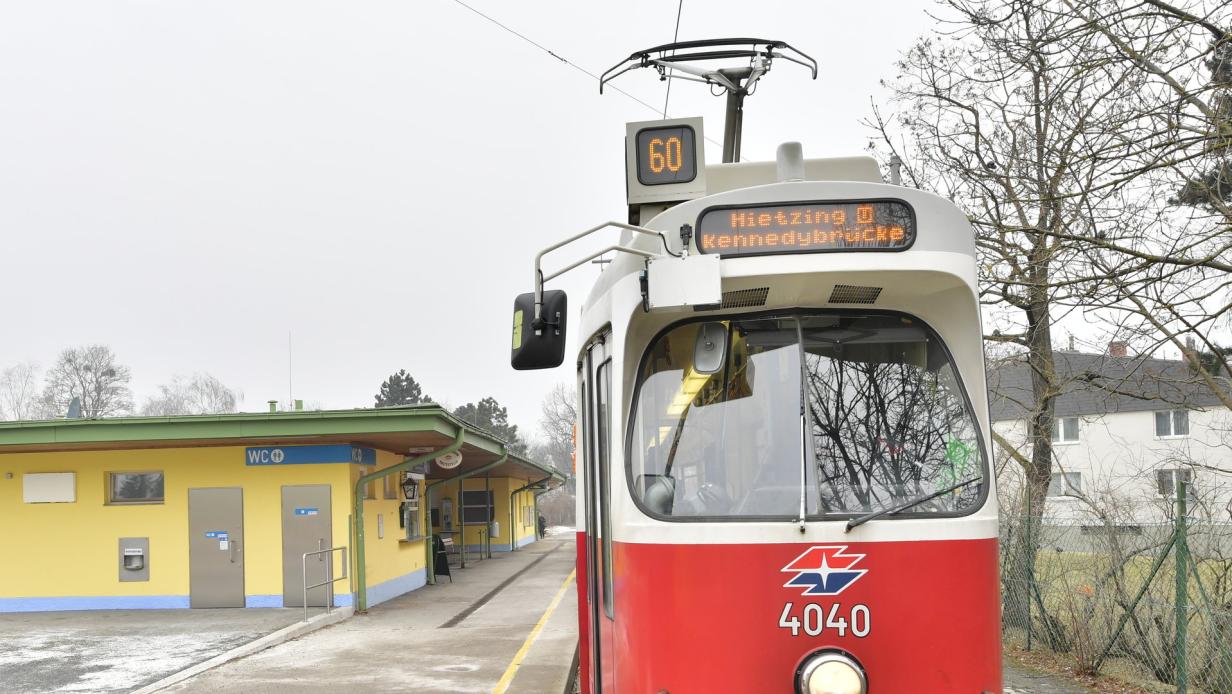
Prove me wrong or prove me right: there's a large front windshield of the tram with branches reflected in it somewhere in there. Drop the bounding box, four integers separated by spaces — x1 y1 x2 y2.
630 313 987 519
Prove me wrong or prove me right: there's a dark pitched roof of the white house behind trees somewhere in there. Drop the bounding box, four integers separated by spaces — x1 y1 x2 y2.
988 351 1222 422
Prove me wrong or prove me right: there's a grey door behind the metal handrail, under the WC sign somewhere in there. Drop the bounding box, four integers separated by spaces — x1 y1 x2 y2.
282 484 340 608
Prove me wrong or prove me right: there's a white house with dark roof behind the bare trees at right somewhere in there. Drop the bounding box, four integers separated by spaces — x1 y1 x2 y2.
988 343 1232 525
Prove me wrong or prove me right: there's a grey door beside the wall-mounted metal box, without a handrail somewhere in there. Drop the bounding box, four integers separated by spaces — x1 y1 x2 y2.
188 487 244 608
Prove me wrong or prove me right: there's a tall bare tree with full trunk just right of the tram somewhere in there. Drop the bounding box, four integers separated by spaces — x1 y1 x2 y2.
877 0 1163 619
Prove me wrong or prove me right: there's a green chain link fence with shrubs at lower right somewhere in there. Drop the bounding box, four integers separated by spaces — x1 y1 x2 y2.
1000 485 1232 694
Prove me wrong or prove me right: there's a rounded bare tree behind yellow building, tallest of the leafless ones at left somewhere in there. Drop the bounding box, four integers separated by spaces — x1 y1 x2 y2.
41 345 133 418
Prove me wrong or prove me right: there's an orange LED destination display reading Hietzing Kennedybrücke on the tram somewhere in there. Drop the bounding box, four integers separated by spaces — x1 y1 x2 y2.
697 200 915 255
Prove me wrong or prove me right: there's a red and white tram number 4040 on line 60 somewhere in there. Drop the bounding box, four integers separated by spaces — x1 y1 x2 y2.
513 39 1002 694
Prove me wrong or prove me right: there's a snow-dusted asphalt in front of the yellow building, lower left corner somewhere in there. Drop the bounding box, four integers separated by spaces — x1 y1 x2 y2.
0 609 303 694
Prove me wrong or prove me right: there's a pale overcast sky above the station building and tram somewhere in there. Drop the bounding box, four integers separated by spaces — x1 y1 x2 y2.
0 0 931 438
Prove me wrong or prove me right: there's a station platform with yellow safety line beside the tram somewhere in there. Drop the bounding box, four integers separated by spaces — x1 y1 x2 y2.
165 533 578 694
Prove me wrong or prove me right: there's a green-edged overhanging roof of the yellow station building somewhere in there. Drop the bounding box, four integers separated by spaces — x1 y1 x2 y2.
0 403 564 482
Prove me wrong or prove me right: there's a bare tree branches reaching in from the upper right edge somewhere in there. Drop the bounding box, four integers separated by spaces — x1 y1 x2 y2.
1063 0 1232 408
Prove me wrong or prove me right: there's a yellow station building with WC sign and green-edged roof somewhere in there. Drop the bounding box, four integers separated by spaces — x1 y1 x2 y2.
0 406 563 613
